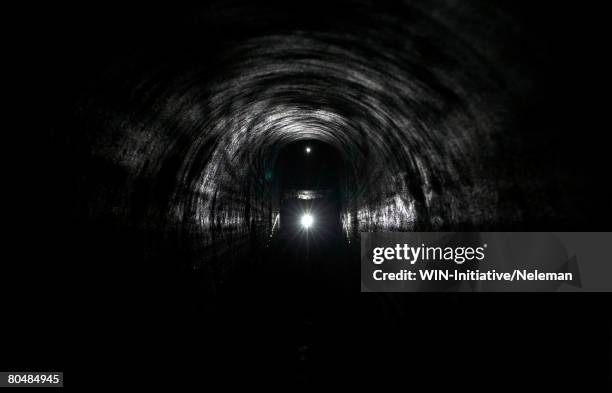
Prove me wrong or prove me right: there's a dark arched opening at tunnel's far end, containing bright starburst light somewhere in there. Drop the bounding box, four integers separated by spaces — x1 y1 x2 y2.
249 140 348 284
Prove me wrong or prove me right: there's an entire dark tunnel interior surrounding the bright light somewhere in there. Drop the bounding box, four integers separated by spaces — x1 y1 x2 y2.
8 0 612 387
